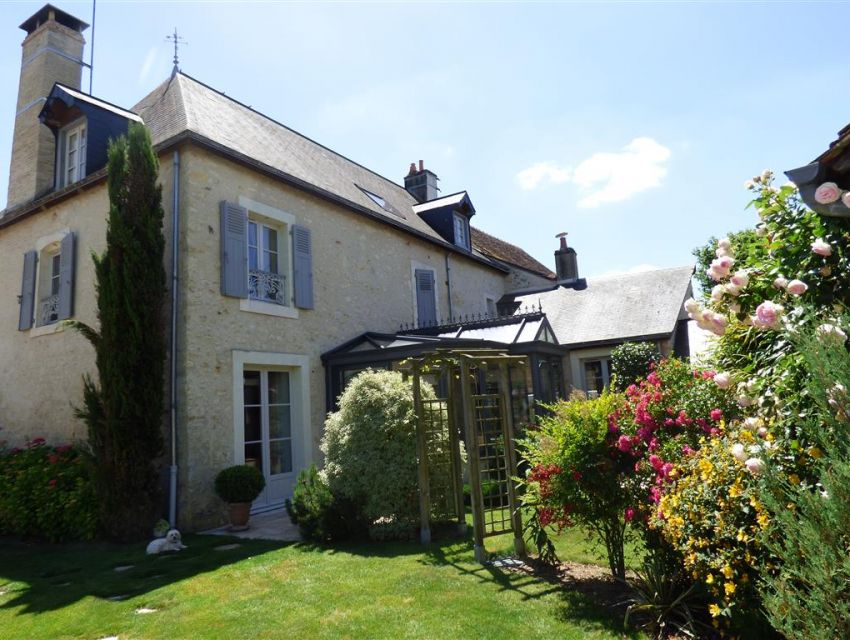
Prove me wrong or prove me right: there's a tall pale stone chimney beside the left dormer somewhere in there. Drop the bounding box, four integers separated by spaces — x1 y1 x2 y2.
6 4 88 208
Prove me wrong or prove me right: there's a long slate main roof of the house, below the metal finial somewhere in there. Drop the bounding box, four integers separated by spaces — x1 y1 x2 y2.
133 73 504 270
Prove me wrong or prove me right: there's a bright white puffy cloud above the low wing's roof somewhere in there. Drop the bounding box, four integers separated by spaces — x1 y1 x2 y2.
516 137 670 209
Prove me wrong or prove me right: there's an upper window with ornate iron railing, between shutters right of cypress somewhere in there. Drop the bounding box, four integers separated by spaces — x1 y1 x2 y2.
248 219 289 306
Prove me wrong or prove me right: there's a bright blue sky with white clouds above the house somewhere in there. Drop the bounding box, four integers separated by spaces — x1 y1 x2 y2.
0 0 850 276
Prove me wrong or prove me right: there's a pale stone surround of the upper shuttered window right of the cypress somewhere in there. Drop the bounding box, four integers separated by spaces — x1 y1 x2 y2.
239 196 298 319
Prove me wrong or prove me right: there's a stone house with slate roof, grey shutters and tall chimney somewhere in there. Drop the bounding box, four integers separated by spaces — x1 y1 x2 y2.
0 4 690 530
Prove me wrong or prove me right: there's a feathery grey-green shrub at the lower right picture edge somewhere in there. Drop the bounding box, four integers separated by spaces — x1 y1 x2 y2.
760 319 850 640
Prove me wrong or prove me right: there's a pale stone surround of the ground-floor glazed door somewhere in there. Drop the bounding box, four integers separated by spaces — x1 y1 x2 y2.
230 349 314 480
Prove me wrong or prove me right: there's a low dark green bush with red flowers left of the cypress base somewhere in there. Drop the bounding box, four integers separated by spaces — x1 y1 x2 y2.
0 438 98 542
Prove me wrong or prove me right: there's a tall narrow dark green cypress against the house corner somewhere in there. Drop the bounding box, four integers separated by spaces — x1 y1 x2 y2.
74 123 166 540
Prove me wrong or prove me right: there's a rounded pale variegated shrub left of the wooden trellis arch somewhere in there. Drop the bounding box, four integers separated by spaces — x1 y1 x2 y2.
322 369 435 538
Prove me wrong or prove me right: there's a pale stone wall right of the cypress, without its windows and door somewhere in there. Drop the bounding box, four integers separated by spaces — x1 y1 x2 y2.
172 147 506 528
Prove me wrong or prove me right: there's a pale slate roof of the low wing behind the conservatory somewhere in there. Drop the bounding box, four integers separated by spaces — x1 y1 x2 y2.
506 266 694 347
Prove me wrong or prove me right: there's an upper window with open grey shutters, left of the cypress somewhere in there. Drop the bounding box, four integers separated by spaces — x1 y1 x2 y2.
18 230 74 331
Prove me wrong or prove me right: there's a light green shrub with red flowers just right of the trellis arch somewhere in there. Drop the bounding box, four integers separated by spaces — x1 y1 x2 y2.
521 393 626 578
